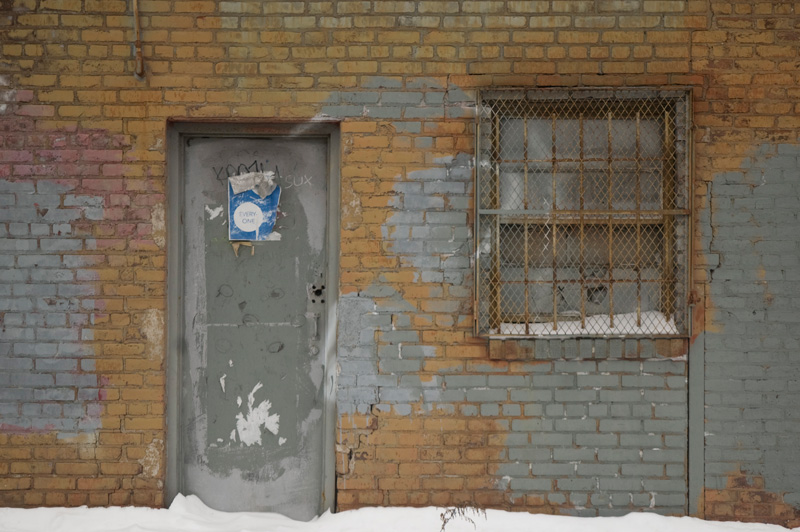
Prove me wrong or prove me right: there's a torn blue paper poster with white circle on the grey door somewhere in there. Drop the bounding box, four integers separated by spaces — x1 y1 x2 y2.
228 172 281 241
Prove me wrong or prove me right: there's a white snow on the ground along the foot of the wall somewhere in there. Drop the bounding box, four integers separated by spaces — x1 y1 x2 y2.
0 495 800 532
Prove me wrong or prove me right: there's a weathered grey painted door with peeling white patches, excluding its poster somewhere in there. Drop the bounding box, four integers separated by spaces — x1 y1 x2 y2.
178 137 328 519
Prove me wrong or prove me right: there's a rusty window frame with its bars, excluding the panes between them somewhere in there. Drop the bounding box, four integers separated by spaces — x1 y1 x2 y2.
474 87 693 339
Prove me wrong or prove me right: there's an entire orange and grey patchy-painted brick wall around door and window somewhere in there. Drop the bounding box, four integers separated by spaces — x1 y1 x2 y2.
0 0 800 523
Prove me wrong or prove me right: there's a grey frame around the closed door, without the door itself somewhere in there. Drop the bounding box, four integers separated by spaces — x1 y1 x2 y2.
164 119 341 514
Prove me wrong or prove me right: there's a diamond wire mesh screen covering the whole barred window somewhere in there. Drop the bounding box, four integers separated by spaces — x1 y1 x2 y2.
477 90 689 337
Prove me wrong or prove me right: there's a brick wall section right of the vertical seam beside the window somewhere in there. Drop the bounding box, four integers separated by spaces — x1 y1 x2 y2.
693 2 800 526
